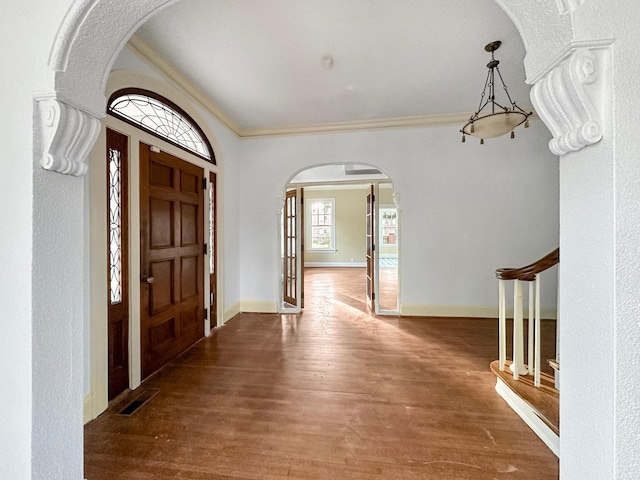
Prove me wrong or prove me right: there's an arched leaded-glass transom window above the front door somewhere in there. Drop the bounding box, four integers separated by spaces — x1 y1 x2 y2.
107 88 216 163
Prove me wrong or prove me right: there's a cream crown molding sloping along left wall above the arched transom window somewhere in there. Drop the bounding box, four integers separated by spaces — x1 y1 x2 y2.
128 33 241 136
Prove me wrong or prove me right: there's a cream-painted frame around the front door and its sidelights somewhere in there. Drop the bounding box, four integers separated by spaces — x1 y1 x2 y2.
84 115 220 421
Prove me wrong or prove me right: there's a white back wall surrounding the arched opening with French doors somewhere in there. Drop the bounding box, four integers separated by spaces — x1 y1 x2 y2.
240 121 558 314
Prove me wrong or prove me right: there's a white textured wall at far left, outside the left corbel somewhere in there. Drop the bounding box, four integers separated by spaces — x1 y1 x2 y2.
0 2 82 479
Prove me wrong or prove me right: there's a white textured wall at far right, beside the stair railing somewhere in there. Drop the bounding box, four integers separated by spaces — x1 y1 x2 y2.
560 1 640 479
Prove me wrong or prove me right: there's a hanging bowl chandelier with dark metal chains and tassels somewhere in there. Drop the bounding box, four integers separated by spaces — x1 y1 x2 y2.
460 40 532 144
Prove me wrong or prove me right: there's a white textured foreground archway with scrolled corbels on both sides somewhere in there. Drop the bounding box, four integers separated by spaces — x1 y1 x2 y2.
29 0 640 478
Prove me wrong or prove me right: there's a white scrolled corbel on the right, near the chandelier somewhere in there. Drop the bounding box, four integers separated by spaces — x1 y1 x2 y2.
531 48 602 155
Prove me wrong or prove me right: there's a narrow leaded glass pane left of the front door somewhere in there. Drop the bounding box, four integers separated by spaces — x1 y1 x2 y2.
108 148 122 305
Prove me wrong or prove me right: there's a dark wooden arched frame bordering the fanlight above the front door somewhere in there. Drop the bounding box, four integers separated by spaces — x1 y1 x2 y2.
107 88 216 165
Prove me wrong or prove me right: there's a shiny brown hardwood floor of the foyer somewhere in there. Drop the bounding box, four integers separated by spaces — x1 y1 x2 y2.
85 272 558 480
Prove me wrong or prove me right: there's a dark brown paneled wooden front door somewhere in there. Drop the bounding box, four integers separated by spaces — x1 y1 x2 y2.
140 143 205 378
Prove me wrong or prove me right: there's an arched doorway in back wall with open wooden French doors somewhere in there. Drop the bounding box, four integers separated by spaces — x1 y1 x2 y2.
279 164 399 315
